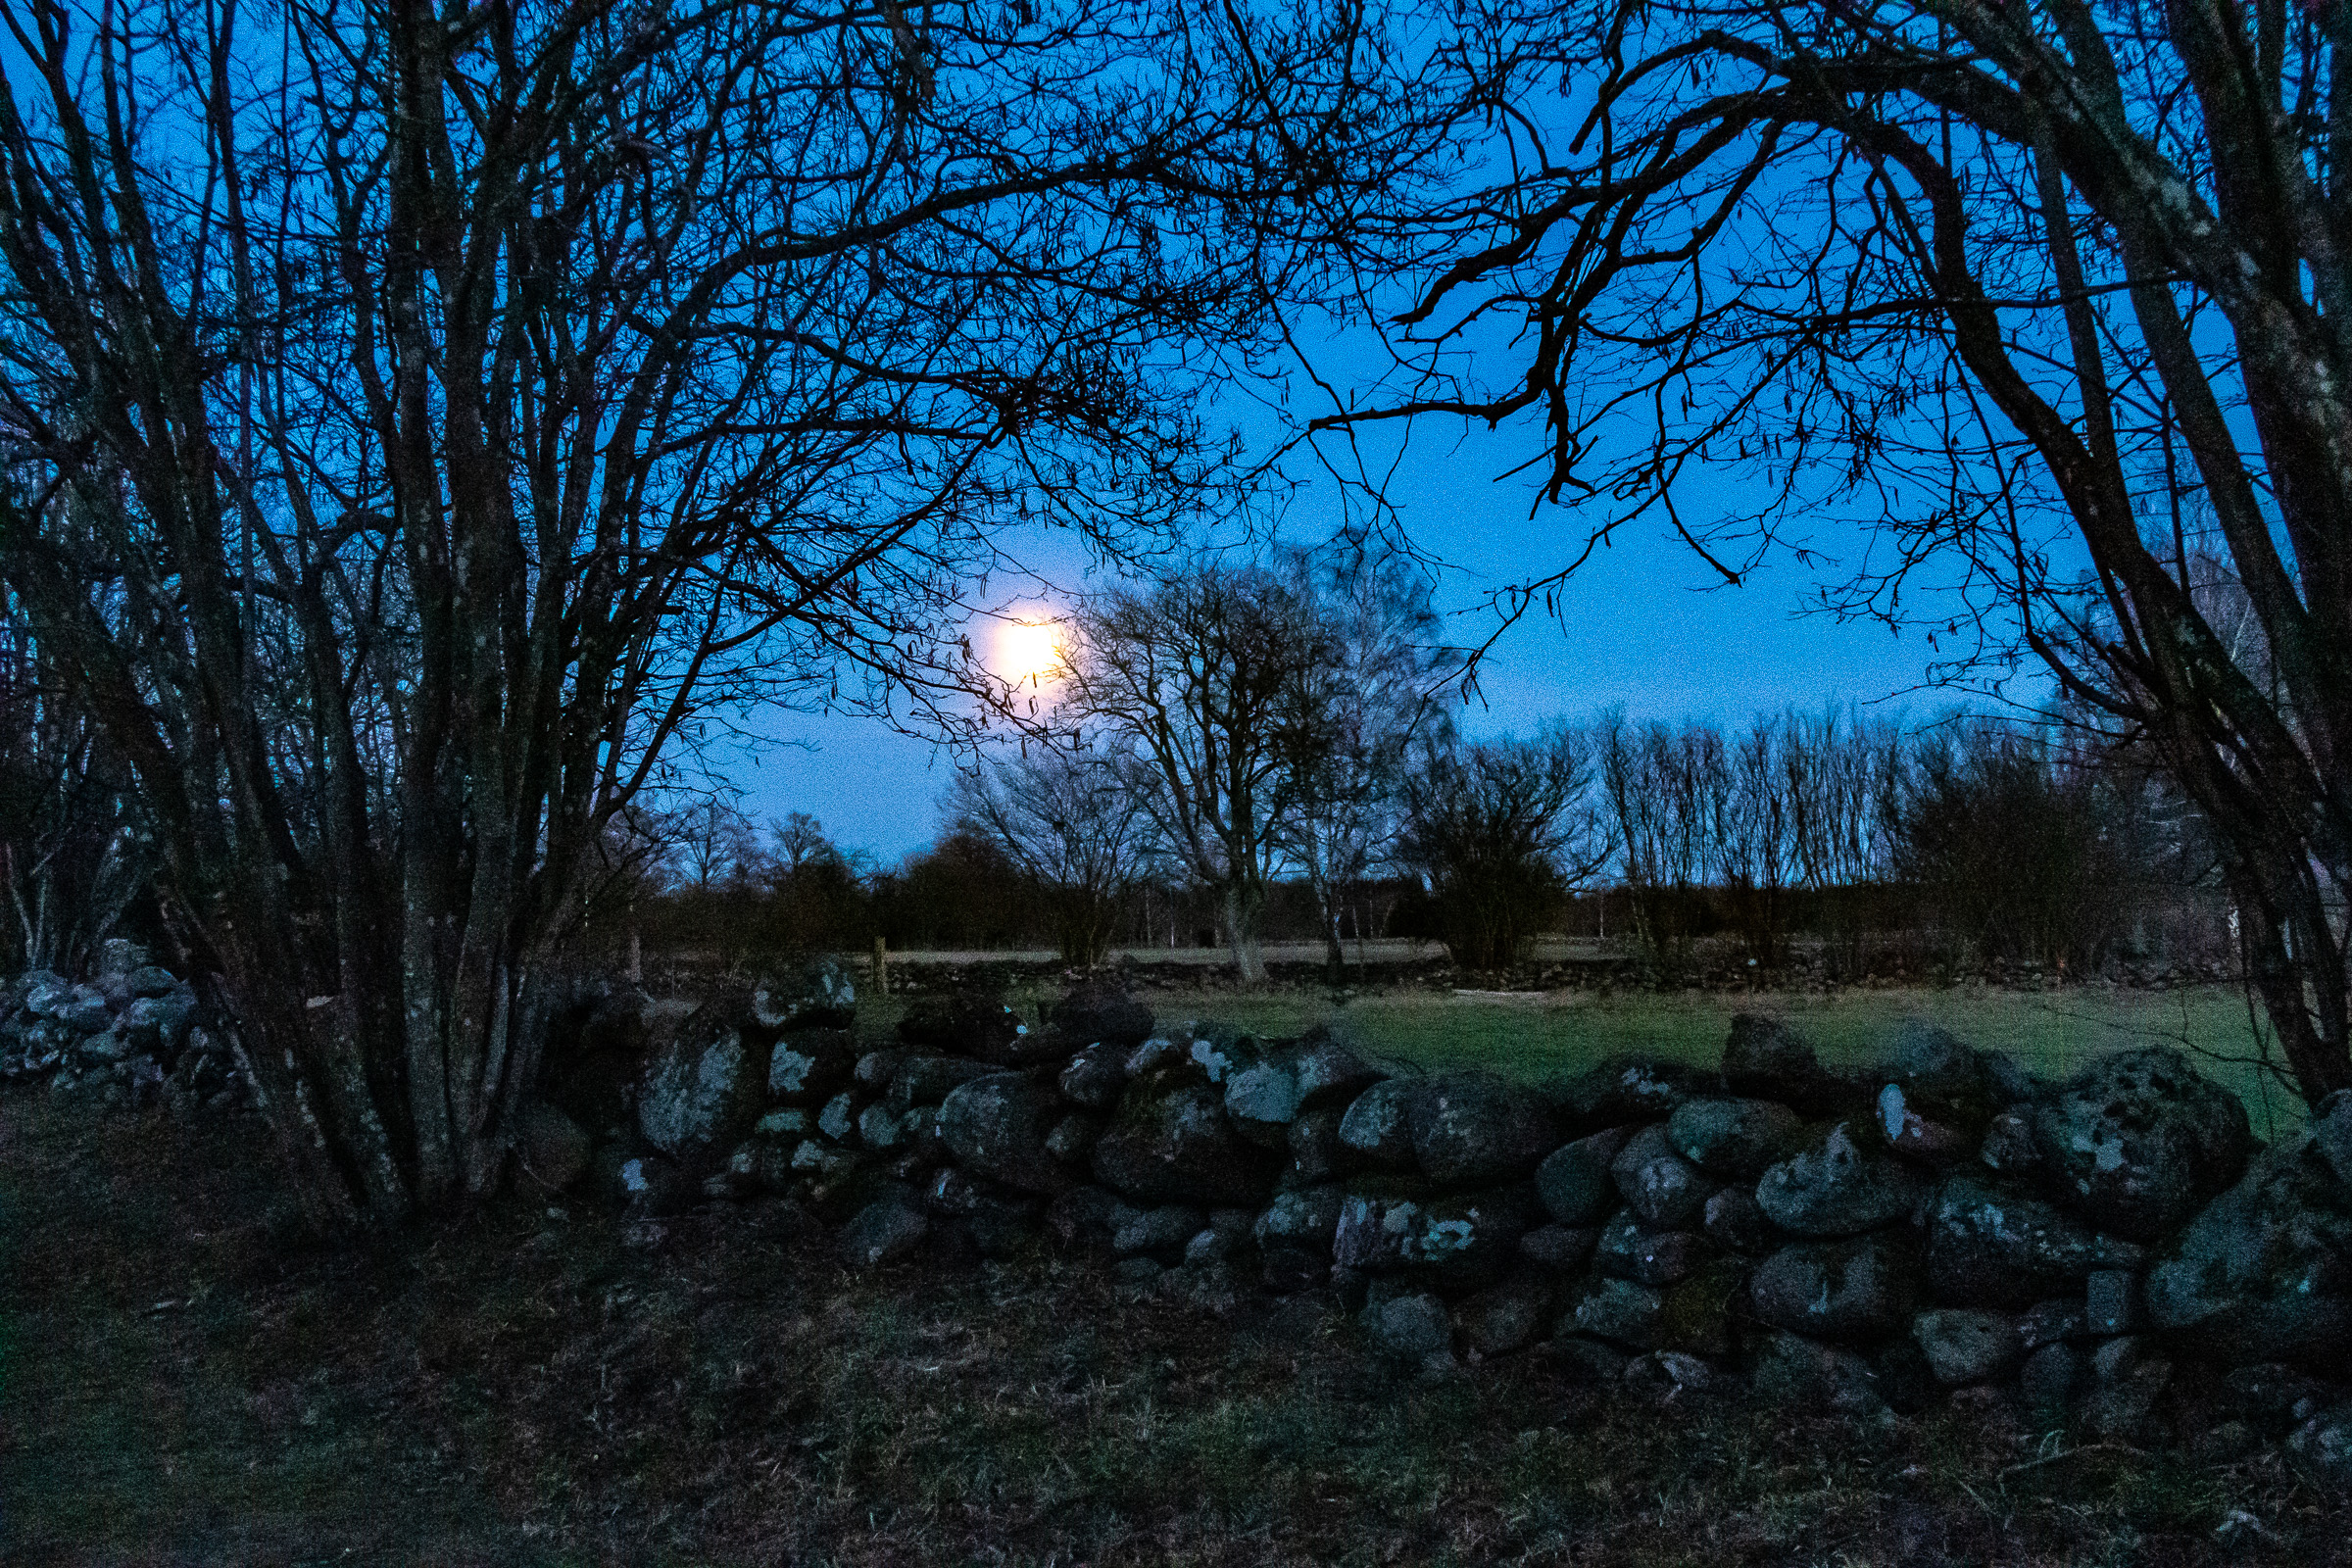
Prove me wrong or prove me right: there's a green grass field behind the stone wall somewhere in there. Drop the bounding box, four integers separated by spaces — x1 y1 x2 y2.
860 985 2303 1138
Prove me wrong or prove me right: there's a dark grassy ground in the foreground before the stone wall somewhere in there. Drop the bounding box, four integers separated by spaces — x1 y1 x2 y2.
0 1096 2352 1566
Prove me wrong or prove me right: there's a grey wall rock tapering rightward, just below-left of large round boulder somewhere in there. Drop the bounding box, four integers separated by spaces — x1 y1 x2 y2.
1927 1175 2145 1307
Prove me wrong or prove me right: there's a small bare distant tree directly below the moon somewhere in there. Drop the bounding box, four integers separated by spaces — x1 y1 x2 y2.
948 745 1152 966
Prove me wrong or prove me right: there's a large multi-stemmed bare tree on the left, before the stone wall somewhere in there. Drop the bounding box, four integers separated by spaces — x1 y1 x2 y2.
0 0 1393 1225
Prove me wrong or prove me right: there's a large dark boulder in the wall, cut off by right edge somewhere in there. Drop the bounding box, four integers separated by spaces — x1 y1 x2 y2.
2147 1133 2352 1373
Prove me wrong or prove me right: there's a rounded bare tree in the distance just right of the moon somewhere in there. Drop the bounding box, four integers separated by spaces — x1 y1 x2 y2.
1065 562 1334 980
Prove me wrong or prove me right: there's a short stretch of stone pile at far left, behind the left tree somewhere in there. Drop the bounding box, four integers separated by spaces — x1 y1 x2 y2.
0 938 252 1109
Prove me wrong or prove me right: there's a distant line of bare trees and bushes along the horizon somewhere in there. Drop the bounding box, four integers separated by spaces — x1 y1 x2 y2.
593 550 2223 976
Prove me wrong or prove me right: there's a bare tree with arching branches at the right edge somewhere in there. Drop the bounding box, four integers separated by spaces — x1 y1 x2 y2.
1298 0 2352 1101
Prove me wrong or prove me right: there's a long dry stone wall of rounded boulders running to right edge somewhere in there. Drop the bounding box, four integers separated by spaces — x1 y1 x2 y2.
551 966 2352 1467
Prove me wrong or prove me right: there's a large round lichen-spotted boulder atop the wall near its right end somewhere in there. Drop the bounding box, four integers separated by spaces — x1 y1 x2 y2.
2034 1046 2253 1242
